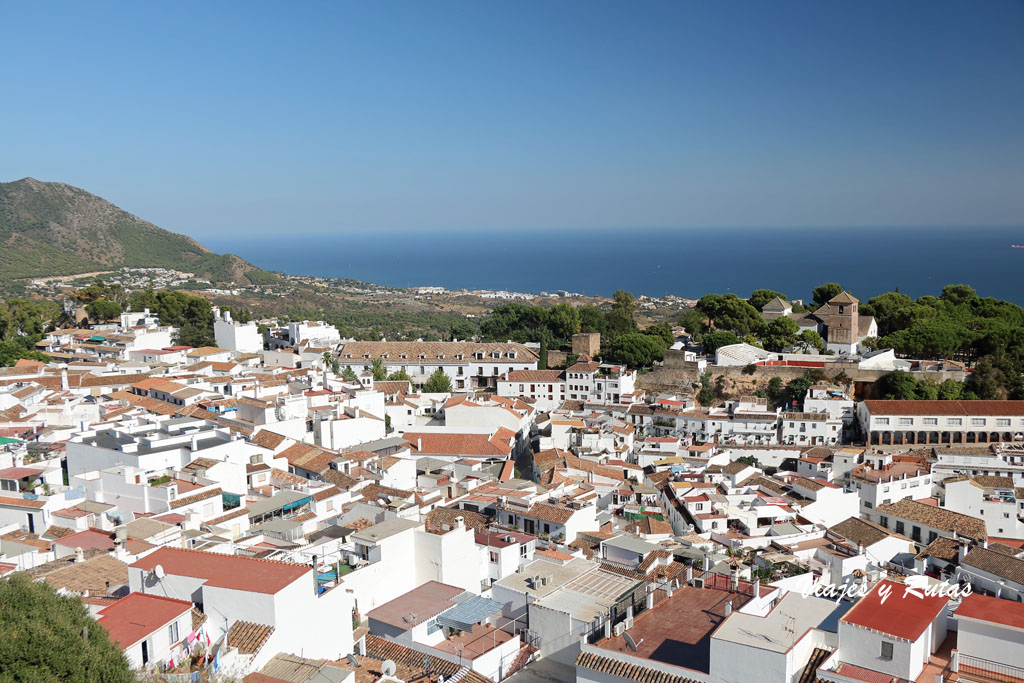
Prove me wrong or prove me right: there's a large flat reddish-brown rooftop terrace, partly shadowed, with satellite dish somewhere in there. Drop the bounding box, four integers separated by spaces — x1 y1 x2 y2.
596 586 751 673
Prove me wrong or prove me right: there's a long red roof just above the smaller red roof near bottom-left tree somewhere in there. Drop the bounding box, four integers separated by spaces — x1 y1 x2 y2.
130 548 312 594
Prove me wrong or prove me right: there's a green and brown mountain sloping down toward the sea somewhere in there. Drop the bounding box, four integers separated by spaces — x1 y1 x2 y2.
0 178 275 285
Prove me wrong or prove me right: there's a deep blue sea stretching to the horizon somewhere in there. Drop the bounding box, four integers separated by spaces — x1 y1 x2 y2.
201 226 1024 305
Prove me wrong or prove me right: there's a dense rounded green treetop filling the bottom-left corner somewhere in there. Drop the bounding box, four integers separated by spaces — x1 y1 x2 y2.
0 572 135 683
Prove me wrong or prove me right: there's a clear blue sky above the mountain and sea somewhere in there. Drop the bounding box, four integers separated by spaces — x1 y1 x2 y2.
0 0 1024 235
